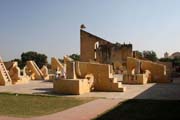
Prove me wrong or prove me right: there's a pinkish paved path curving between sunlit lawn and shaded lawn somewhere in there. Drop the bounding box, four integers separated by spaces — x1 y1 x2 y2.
0 99 123 120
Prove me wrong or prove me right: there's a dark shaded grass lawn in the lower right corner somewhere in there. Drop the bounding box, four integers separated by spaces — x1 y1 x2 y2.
95 100 180 120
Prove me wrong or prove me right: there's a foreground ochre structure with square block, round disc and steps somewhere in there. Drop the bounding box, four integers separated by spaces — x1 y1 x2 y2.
54 56 125 94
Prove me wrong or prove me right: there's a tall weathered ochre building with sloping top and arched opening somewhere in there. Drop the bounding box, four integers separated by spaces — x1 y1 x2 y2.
80 30 133 70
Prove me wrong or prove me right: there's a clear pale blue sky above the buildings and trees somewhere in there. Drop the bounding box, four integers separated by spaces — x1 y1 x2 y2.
0 0 180 60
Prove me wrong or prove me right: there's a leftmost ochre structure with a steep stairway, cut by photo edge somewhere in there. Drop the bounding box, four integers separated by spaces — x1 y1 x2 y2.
0 58 12 85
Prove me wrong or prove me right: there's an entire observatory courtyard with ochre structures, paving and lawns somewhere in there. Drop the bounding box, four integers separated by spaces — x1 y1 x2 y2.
0 29 180 120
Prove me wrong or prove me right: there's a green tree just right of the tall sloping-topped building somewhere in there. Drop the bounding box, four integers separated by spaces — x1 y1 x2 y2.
143 50 158 61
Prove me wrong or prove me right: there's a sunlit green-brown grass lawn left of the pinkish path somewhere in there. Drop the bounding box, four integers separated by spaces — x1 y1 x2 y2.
0 94 94 117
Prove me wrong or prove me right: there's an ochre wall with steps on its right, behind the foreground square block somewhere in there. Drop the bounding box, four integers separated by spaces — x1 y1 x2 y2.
75 62 125 92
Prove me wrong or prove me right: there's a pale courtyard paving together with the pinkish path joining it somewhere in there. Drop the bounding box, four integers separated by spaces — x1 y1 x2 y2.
0 79 180 120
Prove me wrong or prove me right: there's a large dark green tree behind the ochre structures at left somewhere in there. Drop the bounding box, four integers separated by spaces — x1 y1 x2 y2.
21 51 47 68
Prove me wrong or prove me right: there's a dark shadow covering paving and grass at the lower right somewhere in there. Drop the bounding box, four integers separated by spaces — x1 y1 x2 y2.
95 78 180 120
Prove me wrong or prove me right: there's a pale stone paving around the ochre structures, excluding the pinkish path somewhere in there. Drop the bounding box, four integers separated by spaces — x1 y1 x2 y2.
0 79 180 99
